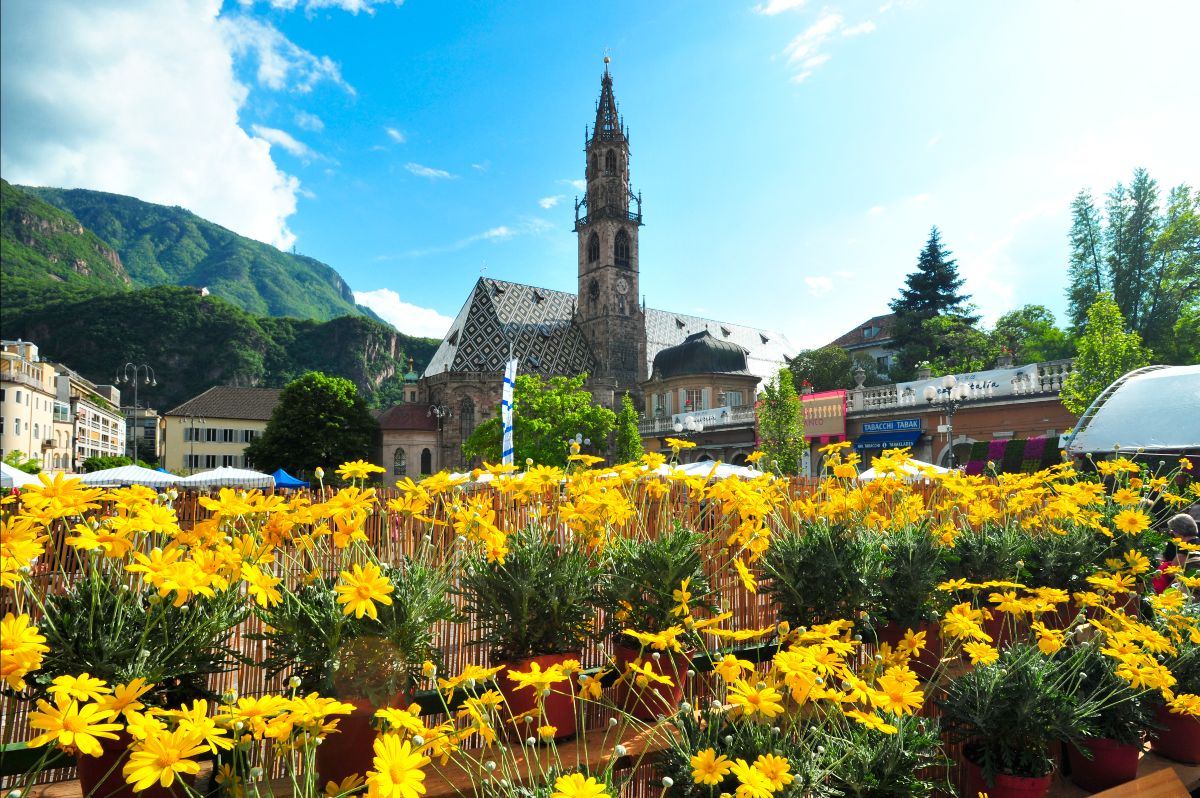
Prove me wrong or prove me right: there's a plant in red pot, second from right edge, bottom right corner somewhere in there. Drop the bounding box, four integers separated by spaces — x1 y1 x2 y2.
1067 644 1154 792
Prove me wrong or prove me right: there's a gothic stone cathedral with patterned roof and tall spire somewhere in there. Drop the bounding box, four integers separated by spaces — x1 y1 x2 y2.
379 59 796 476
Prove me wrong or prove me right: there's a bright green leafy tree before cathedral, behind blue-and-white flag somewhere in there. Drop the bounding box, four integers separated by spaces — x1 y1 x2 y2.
462 374 617 466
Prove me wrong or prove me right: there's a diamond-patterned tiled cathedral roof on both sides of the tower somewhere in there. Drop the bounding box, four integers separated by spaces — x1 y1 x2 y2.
425 277 796 379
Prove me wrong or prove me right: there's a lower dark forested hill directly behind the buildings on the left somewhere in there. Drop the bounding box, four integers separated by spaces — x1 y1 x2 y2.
4 286 438 410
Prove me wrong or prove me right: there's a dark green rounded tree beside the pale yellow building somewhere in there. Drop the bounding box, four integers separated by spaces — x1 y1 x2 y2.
246 371 378 475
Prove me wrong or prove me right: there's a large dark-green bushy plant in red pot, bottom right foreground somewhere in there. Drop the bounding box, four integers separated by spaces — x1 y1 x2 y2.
938 642 1103 798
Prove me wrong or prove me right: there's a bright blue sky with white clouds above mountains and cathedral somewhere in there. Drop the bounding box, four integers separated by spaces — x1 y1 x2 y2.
0 0 1200 347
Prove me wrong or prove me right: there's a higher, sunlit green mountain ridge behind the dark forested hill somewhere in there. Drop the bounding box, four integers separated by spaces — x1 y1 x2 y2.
16 184 369 320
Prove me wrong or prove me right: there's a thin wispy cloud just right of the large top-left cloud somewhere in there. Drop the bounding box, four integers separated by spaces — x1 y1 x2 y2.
217 16 354 95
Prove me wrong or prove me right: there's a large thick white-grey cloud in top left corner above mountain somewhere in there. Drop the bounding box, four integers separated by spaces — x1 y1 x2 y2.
0 0 300 248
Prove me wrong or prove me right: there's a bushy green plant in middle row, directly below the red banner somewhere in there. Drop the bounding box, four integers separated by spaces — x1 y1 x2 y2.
760 521 883 626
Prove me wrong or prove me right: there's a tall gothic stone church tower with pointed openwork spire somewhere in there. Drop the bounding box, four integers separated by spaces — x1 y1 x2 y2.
575 56 646 400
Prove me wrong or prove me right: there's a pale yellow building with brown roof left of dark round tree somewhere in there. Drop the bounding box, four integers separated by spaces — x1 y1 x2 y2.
162 385 282 474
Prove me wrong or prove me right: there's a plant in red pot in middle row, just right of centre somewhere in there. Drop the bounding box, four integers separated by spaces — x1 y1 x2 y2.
605 522 714 720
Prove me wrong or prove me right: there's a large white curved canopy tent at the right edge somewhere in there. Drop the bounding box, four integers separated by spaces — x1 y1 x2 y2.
1066 366 1200 457
